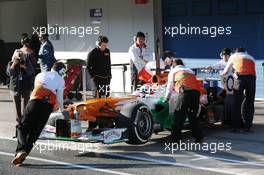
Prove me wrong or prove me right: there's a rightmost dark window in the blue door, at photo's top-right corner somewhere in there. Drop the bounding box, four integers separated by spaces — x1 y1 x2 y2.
245 0 264 14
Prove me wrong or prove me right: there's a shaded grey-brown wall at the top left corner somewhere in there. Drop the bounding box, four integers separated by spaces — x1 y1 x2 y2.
0 0 46 42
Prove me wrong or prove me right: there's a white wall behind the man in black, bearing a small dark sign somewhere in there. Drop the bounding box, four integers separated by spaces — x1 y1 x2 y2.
47 0 154 92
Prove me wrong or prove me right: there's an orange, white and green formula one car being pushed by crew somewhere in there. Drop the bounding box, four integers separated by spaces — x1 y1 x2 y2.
41 65 234 144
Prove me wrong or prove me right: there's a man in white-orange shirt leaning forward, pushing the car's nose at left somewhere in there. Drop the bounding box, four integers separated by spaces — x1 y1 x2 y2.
12 62 66 166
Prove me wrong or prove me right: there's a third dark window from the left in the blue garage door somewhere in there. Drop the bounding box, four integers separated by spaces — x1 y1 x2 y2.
218 0 239 15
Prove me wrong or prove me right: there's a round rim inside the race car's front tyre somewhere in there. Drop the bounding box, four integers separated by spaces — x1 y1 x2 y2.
137 111 151 136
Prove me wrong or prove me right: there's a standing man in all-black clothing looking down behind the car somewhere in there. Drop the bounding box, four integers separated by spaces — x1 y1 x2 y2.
87 36 112 98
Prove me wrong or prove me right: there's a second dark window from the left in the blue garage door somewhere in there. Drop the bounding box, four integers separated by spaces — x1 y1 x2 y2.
192 0 212 16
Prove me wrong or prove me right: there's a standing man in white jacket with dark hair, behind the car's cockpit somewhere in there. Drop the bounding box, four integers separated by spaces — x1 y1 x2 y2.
128 32 153 91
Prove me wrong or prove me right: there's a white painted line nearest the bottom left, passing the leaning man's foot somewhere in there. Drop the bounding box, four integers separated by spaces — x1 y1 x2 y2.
0 151 135 175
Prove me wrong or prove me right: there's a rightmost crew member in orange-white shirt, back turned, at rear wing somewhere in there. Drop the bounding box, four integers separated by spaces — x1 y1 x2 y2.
222 48 256 132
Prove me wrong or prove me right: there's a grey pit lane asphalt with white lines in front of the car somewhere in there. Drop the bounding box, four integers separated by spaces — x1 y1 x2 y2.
0 87 264 175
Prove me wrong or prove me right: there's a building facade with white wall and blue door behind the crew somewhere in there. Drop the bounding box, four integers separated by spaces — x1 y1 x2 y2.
0 0 264 96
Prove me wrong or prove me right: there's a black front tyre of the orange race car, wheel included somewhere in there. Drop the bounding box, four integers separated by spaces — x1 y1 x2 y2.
118 103 153 144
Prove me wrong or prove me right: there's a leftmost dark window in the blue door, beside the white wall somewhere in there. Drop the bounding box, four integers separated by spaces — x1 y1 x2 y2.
168 2 187 17
